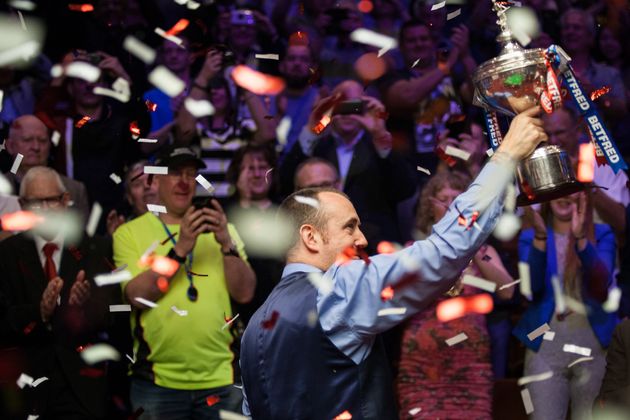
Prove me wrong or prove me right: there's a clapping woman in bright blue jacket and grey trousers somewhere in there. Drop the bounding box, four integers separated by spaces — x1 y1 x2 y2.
514 192 617 419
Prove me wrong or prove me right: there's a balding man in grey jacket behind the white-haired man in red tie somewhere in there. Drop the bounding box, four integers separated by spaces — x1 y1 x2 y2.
5 115 90 220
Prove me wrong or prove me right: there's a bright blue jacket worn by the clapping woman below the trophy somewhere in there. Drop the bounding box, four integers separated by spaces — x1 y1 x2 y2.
513 224 618 351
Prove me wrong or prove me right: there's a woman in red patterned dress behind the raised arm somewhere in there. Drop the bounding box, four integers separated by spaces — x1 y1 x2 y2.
396 172 513 419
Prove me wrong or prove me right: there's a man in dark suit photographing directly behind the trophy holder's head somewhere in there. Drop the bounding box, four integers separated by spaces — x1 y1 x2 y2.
280 80 416 252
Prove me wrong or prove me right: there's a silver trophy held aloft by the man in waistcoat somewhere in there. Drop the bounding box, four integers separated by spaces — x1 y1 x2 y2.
473 0 583 205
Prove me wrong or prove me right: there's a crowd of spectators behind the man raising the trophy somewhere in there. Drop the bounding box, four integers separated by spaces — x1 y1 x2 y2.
0 0 630 419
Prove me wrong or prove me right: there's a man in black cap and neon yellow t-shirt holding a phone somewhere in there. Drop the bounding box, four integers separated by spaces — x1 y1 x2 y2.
114 147 256 419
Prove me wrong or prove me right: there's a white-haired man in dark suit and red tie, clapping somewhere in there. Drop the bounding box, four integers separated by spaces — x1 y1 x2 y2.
0 166 117 419
